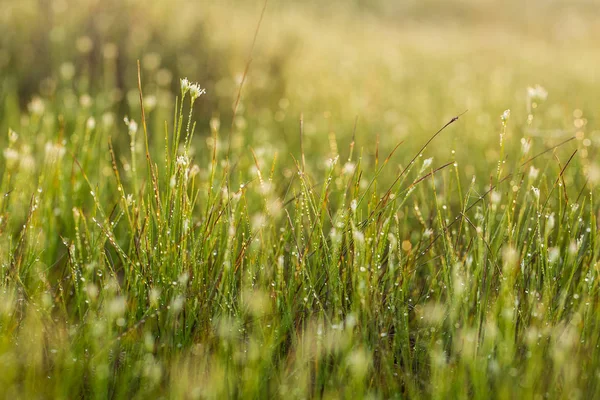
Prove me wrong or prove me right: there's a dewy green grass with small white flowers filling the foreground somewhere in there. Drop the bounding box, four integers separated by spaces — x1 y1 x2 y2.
0 64 600 398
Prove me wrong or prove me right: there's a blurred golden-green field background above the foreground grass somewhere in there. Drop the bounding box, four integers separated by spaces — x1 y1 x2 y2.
0 0 600 184
